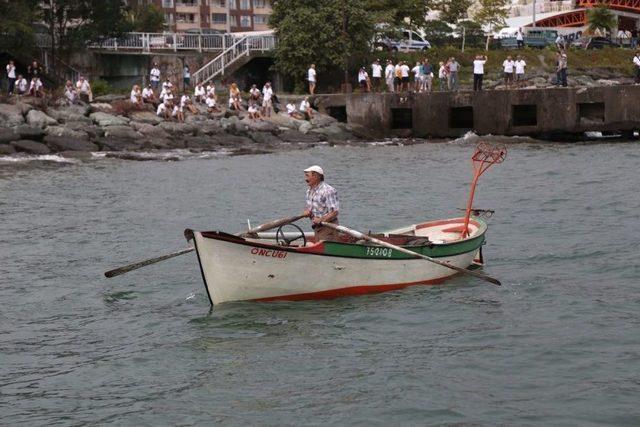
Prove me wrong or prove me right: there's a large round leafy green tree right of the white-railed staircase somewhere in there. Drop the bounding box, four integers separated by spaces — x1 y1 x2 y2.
269 0 374 89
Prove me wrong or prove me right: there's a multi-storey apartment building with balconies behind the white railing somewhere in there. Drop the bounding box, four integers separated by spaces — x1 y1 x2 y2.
128 0 272 32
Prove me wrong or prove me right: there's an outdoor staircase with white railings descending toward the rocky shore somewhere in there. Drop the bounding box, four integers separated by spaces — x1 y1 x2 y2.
191 35 276 84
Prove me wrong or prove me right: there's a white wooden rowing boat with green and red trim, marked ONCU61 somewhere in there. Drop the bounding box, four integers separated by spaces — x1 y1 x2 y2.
185 217 487 304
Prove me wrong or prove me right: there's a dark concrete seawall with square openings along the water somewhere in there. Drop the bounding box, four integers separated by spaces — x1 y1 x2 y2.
315 85 640 138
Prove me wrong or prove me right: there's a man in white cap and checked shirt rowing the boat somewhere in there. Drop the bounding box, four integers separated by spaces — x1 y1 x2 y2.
304 166 340 241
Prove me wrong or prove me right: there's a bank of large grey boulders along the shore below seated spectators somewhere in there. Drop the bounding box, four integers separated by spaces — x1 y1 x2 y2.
0 95 366 160
